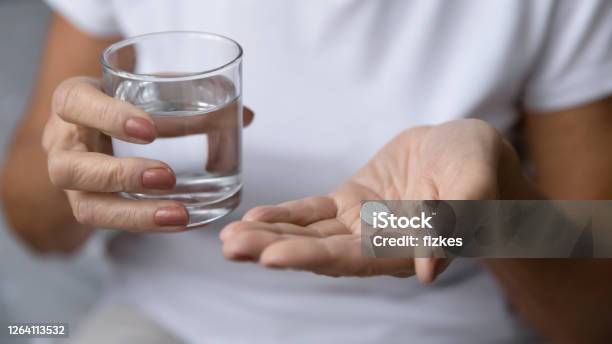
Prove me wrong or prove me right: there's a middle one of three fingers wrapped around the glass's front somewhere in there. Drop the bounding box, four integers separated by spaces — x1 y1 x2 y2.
48 150 176 193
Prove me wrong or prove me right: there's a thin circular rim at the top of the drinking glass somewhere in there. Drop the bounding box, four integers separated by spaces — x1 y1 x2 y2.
100 31 243 82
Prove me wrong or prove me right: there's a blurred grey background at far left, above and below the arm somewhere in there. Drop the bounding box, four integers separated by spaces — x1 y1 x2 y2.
0 0 108 343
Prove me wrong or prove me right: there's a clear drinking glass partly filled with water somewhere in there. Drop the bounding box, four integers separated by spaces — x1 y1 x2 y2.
102 31 242 227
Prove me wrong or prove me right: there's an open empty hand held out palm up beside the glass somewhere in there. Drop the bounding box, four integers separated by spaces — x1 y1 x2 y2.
220 120 521 282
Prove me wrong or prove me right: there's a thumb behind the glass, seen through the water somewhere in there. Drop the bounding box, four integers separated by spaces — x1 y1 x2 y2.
153 102 255 137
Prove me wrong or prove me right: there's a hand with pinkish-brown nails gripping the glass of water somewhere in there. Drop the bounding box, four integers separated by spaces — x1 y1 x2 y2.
43 77 253 232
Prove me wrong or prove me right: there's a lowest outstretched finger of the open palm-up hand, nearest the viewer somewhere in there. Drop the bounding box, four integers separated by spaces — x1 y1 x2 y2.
260 235 414 276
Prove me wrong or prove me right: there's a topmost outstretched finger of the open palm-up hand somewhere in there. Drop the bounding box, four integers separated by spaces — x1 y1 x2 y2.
244 196 337 226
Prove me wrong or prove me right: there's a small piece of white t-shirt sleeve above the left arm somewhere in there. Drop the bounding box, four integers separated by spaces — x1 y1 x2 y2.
45 0 120 37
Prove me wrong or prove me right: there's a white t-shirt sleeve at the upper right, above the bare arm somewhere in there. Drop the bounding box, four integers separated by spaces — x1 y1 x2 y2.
524 0 612 112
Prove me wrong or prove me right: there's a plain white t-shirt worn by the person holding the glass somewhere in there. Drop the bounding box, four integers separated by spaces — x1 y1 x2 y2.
48 0 612 343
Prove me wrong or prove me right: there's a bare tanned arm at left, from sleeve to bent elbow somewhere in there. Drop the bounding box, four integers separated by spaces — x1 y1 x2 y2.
2 15 114 252
